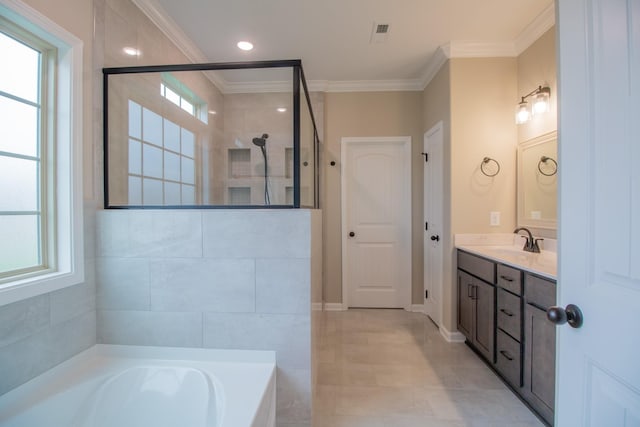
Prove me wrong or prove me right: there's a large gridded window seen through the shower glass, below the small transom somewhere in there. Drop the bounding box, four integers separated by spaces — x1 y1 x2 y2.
129 100 196 206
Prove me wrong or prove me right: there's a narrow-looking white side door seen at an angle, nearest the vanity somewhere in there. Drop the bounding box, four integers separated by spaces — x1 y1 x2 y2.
424 122 444 326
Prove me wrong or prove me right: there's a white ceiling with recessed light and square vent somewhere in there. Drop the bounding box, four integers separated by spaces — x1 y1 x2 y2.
134 0 553 90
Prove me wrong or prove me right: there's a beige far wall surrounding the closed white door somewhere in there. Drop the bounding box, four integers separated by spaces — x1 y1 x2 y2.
321 92 423 304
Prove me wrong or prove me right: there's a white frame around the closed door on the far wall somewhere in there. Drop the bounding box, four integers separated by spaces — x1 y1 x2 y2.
340 136 412 310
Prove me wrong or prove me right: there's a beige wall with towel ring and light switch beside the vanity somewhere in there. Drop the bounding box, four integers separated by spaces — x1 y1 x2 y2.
422 58 517 331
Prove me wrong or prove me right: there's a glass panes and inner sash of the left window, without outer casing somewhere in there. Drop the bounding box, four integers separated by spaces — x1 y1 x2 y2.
0 28 49 280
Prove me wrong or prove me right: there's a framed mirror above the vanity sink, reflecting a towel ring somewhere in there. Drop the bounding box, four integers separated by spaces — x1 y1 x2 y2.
518 131 558 230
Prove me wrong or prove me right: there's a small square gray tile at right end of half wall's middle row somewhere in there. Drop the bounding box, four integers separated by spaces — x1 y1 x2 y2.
256 259 311 314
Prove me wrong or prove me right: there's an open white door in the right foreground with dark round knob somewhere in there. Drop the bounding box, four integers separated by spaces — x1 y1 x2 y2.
556 0 640 427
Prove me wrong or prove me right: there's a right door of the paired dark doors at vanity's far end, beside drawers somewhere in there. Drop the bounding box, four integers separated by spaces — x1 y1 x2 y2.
473 279 496 363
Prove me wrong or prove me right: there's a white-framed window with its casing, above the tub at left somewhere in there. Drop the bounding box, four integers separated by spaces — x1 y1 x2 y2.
0 1 84 305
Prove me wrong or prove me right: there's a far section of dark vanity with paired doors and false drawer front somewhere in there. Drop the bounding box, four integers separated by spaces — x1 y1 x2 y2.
457 251 496 363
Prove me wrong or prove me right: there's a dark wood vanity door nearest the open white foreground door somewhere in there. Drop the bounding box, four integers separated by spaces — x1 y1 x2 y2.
523 304 556 424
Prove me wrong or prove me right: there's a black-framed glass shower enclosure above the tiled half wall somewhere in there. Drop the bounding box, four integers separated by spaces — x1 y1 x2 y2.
103 60 320 208
